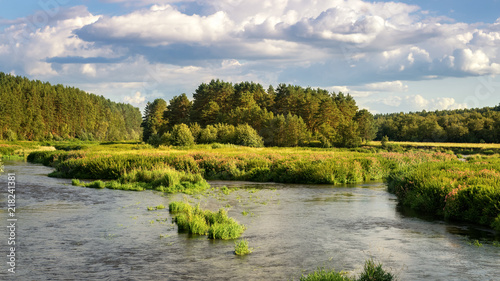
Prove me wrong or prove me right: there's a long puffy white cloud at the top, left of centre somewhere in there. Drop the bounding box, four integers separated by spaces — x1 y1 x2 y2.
77 5 233 46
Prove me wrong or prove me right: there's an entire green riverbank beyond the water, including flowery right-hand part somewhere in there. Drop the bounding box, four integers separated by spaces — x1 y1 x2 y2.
22 143 500 231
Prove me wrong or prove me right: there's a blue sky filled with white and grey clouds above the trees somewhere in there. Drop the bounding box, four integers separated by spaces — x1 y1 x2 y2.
0 0 500 114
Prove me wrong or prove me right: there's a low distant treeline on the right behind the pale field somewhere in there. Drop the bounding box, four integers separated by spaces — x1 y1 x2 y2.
375 105 500 143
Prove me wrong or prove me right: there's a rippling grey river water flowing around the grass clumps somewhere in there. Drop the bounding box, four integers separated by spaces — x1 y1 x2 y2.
0 161 500 280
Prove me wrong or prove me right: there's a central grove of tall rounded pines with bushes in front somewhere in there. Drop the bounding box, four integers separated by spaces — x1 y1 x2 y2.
142 80 376 147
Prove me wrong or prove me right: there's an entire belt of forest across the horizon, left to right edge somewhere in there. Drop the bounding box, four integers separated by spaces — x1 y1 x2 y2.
0 72 500 147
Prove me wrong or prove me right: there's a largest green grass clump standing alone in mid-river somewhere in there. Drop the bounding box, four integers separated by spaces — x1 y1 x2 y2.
169 201 245 240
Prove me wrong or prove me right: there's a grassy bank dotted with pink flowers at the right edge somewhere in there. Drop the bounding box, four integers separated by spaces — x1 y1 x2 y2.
388 156 500 232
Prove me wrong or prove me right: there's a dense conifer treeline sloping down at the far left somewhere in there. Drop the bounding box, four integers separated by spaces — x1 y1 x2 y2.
0 72 141 140
